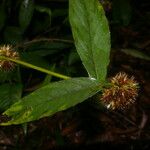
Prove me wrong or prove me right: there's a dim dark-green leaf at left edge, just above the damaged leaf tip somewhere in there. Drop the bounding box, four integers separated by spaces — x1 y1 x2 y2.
0 83 22 112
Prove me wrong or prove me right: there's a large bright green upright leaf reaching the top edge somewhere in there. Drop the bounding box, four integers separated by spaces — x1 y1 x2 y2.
69 0 110 81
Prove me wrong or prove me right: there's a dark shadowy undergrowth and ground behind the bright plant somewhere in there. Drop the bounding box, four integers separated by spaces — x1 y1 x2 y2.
0 0 150 150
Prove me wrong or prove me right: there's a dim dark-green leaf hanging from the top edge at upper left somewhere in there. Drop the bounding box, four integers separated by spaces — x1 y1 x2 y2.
19 0 34 31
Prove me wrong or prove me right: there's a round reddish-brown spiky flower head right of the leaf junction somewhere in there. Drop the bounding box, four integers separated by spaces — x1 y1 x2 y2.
101 72 138 110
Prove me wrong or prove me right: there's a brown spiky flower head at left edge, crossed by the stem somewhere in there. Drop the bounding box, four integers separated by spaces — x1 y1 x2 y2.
0 45 19 71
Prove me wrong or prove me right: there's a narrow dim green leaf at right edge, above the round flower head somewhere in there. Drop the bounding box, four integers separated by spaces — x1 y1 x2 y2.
121 49 150 60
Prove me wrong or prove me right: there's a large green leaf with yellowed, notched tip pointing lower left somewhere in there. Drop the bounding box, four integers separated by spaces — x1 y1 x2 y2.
1 78 101 125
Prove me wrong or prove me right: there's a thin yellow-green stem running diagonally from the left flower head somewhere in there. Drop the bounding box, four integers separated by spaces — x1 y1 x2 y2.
0 56 70 79
